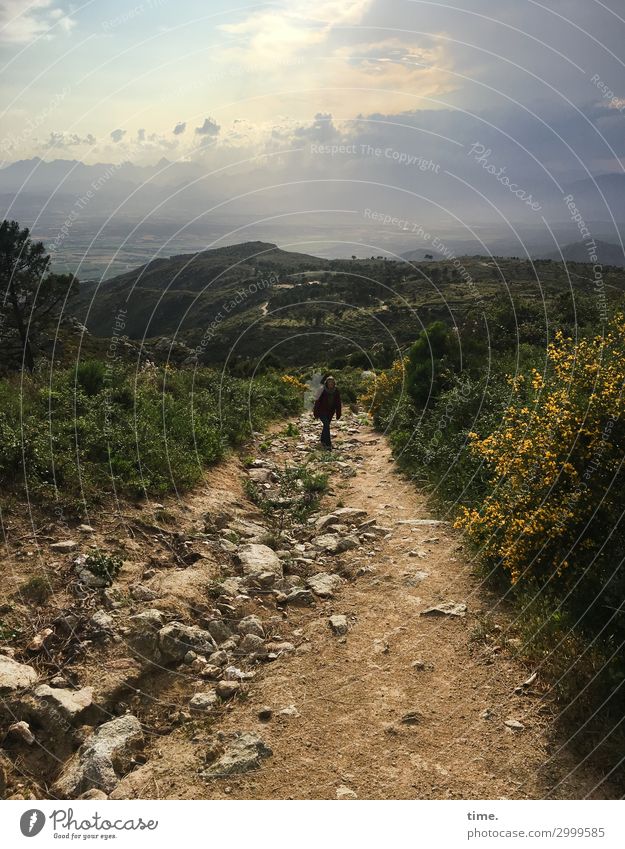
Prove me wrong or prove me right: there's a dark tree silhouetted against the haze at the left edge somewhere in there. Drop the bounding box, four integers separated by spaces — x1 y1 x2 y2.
0 221 78 371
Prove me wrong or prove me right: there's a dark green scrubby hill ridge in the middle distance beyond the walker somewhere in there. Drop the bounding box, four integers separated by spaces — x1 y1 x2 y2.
73 242 623 367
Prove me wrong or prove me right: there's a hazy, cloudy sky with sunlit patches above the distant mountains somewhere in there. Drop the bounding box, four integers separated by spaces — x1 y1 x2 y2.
0 0 625 264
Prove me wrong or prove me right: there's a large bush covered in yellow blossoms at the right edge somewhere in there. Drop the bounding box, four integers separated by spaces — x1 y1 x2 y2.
456 315 625 583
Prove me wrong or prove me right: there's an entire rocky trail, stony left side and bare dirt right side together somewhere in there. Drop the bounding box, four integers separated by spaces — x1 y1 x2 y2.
0 414 606 799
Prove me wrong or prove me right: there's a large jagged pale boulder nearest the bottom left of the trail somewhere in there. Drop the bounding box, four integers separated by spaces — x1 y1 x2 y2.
52 714 144 799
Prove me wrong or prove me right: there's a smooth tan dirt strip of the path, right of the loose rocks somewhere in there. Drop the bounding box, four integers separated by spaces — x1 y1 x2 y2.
112 412 606 799
